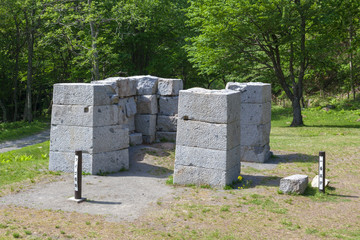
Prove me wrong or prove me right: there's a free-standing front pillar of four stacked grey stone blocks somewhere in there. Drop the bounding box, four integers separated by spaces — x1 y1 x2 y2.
174 88 241 187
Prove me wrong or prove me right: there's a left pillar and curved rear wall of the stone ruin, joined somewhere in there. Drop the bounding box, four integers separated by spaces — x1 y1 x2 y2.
49 76 183 174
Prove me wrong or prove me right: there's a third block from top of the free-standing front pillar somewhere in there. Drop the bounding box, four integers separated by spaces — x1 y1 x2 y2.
175 145 240 171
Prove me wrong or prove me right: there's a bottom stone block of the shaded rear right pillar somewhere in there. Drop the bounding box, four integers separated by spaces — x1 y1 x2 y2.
240 144 271 163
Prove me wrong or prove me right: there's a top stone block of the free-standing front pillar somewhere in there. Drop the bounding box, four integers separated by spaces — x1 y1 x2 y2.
178 88 241 123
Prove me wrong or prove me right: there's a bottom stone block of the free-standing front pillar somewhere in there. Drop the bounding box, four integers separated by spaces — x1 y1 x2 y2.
174 164 240 188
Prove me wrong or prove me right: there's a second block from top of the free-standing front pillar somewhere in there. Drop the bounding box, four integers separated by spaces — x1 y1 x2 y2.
176 119 240 150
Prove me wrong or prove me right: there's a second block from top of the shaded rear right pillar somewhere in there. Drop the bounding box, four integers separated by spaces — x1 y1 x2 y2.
240 102 271 124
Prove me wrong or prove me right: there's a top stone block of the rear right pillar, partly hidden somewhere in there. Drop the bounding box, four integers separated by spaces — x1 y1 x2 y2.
226 82 271 103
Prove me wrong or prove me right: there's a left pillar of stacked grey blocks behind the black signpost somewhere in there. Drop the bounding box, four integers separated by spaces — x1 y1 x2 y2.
49 83 129 173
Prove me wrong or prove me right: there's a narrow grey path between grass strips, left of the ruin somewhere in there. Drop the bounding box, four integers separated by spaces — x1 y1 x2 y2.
0 129 50 153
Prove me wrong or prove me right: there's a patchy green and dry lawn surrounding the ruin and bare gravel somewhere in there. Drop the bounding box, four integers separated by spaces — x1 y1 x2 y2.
0 106 360 239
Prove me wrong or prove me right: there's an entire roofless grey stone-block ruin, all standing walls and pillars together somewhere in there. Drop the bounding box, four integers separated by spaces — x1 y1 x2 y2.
49 76 271 187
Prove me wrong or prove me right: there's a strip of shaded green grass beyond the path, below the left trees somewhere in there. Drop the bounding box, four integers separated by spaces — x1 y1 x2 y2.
0 119 49 142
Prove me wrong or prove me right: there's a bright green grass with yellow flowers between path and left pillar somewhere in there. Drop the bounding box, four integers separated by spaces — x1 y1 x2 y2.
0 141 50 189
